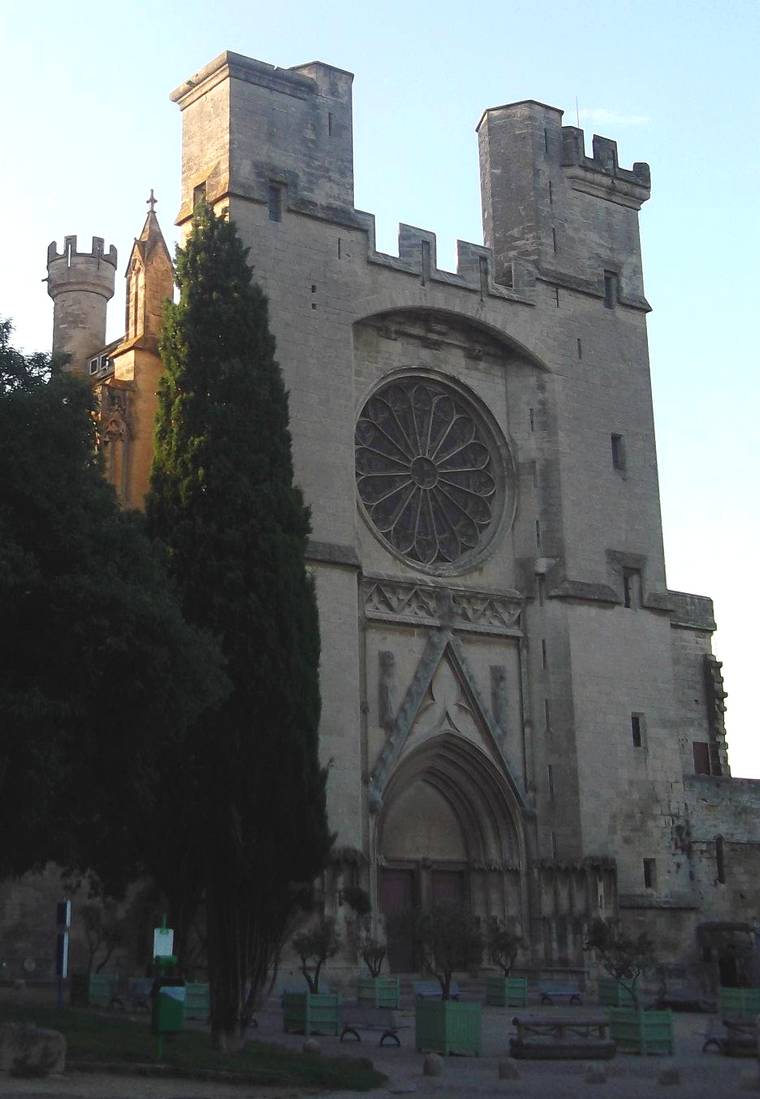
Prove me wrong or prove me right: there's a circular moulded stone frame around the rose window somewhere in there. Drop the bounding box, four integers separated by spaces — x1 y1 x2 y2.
354 367 517 576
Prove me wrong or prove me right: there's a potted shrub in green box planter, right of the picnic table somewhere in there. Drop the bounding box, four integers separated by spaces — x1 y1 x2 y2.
584 917 673 1054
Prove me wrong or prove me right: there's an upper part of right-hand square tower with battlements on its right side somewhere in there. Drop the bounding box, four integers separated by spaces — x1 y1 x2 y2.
478 100 650 312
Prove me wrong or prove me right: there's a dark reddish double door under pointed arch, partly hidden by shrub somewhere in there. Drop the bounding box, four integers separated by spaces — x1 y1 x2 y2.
380 866 467 973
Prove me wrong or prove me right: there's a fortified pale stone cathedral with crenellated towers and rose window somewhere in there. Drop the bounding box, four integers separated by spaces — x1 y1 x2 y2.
43 53 760 972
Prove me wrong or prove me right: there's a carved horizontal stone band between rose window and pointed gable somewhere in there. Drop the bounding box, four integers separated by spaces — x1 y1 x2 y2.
361 577 523 636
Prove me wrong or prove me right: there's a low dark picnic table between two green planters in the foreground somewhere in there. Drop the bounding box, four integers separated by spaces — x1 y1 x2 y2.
510 1013 616 1061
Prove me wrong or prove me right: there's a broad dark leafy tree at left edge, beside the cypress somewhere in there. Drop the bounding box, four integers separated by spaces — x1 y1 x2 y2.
0 321 225 895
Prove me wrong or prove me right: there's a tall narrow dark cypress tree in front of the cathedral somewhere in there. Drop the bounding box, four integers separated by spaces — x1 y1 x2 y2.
147 204 331 1045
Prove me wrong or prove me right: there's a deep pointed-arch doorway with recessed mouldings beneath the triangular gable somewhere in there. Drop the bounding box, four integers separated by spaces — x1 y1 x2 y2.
377 731 525 973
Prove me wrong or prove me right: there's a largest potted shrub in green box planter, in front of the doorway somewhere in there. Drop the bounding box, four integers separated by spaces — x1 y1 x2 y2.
414 903 483 1056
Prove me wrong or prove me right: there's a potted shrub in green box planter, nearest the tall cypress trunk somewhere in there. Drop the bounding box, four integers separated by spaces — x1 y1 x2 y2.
282 917 340 1035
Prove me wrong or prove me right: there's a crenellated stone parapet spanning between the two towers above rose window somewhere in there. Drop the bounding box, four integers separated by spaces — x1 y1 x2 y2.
356 210 536 306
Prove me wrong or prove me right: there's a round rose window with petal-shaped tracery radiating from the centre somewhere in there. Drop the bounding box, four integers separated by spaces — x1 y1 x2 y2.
356 378 503 570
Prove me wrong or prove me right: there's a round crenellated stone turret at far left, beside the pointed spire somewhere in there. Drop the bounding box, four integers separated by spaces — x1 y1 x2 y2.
47 236 116 373
